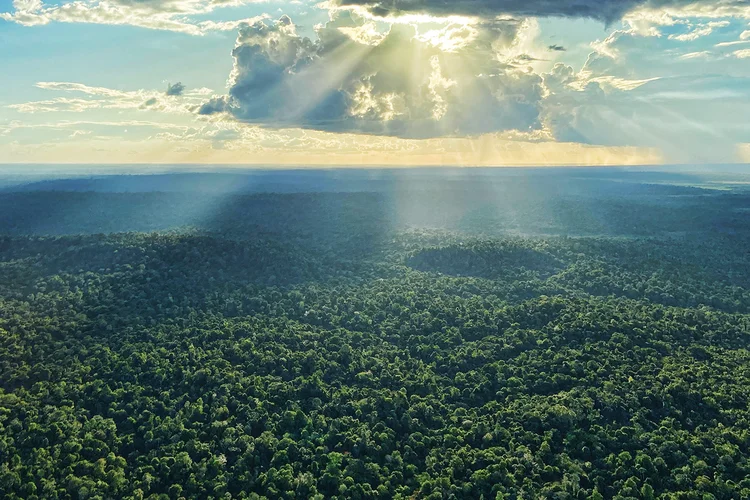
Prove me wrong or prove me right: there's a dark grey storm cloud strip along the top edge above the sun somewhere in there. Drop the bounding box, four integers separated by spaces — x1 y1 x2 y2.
333 0 750 22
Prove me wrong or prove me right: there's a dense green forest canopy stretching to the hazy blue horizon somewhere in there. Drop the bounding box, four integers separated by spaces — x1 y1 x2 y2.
0 170 750 500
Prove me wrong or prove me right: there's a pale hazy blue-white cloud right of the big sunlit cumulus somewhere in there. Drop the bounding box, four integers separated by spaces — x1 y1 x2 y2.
524 13 750 163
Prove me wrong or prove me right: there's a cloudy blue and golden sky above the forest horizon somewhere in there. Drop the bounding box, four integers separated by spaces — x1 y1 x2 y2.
0 0 750 166
